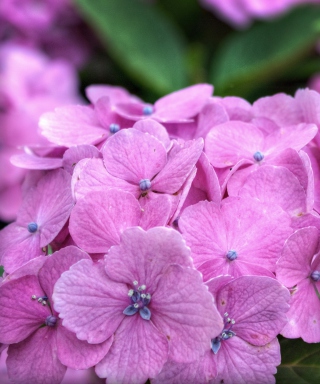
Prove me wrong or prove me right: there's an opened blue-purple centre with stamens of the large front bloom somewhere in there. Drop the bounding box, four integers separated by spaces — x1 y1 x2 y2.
123 281 151 320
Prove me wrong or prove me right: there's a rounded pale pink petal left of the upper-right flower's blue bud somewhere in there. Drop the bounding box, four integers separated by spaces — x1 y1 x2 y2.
205 121 264 168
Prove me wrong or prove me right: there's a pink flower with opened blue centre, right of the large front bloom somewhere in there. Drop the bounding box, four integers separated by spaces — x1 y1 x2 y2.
205 276 290 384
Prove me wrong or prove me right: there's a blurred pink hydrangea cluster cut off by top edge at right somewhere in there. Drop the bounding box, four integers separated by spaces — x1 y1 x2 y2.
200 0 319 28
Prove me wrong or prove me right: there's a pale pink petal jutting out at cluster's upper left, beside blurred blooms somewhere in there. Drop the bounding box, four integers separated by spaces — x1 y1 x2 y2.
39 105 108 147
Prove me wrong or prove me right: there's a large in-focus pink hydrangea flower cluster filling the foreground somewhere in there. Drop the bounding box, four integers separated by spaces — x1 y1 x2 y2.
0 84 320 384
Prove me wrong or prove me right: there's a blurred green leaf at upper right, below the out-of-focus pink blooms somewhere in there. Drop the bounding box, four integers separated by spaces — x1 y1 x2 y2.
211 7 320 96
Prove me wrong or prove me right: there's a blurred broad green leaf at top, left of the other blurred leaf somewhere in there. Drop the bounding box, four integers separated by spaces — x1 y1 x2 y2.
76 0 186 95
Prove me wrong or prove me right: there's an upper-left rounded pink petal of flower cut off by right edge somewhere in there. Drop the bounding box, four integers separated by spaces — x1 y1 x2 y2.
276 227 319 287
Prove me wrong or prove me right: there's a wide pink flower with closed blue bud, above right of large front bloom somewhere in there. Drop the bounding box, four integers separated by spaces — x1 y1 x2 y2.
179 198 292 281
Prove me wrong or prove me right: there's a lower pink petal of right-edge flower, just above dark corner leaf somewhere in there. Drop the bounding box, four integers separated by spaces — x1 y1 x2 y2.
281 279 320 343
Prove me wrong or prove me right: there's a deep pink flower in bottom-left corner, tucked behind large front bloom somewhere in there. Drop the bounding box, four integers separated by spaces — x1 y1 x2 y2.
0 247 112 384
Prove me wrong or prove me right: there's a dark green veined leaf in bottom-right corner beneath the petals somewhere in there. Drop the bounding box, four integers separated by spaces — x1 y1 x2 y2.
276 339 320 384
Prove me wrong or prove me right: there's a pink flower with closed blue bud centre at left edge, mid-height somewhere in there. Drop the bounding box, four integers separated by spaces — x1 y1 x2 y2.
0 169 74 273
